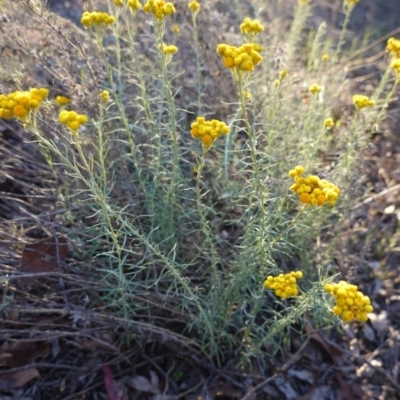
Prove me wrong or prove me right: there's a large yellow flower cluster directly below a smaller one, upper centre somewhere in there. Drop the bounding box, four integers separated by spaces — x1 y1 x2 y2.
217 43 263 72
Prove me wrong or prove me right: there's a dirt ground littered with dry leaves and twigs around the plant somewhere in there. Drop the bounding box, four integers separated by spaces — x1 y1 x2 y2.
0 0 400 400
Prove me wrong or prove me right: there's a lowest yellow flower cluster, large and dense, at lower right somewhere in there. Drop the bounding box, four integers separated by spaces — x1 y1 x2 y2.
324 281 373 322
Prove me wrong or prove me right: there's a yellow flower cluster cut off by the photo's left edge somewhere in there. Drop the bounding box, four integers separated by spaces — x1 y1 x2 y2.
0 88 49 120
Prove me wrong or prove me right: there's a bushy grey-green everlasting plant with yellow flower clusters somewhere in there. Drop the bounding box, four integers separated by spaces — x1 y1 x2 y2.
0 0 388 366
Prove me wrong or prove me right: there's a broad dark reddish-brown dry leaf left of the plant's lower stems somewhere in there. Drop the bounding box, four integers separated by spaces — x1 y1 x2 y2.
21 236 68 280
